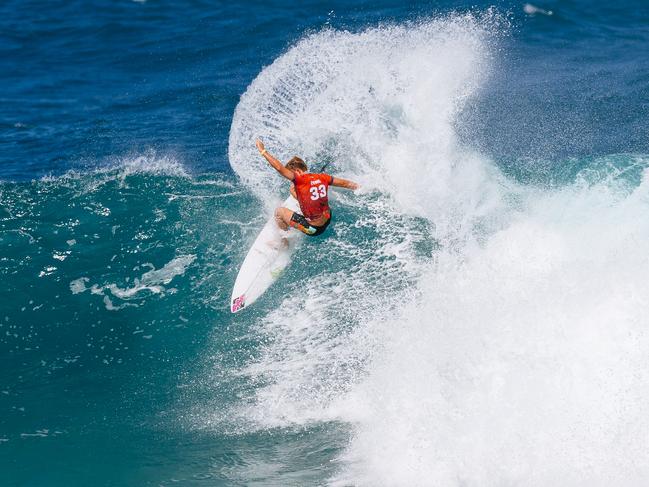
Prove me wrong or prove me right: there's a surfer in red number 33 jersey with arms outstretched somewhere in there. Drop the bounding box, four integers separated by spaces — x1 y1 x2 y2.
256 140 358 237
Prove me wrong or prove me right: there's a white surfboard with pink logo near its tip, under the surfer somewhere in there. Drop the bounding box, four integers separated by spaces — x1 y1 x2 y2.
230 196 304 313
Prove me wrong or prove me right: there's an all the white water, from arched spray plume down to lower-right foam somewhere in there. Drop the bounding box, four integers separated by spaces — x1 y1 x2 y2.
225 9 649 486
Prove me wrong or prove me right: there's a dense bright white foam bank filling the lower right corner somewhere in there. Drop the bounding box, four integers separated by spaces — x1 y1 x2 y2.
334 172 649 486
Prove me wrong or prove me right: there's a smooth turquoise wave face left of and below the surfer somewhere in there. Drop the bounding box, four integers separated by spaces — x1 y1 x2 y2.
2 163 426 485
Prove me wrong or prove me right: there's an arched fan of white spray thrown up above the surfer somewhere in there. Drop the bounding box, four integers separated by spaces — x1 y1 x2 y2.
228 12 501 225
